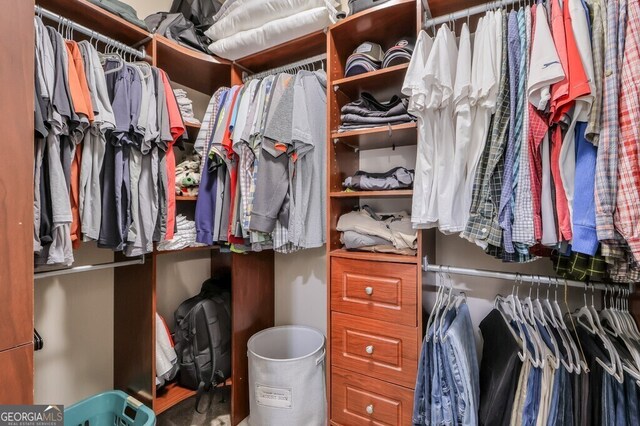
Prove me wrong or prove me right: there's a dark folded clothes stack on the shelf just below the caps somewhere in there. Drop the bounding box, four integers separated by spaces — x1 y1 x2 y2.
338 92 416 132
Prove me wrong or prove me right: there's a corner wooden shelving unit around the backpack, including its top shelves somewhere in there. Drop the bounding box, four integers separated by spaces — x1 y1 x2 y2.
35 0 270 425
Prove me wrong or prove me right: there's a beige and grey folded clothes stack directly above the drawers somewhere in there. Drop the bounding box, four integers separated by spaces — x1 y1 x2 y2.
336 206 418 256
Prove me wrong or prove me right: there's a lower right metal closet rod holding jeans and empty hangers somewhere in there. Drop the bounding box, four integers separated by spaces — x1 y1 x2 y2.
422 257 634 292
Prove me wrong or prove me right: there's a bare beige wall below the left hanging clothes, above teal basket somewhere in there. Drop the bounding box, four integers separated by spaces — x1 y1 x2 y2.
34 244 113 405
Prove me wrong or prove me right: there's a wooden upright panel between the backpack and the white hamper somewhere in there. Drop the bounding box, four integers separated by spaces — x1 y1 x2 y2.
228 250 275 426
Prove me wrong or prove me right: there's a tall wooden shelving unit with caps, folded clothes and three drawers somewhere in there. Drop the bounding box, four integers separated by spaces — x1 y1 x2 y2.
327 0 423 426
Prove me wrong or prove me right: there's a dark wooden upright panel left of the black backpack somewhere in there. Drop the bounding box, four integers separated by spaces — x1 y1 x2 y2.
113 253 156 408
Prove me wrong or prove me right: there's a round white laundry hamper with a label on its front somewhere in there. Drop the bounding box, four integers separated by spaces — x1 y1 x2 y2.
247 325 327 426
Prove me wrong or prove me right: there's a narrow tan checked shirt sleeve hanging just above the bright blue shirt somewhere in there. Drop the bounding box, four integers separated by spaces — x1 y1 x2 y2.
585 0 607 145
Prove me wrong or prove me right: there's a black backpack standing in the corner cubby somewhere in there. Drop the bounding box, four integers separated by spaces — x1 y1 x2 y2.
174 276 231 410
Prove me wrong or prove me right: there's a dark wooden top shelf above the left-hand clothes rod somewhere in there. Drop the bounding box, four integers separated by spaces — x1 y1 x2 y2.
36 0 151 45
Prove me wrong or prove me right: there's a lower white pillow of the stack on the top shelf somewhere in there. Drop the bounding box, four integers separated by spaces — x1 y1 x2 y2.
209 6 331 61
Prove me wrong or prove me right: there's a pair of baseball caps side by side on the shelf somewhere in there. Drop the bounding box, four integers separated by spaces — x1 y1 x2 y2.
344 37 415 77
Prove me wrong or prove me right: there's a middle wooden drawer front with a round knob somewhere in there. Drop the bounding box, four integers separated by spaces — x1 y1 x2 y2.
331 312 418 388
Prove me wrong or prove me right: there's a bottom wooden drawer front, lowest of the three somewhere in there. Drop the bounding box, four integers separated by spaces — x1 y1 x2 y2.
331 368 413 426
